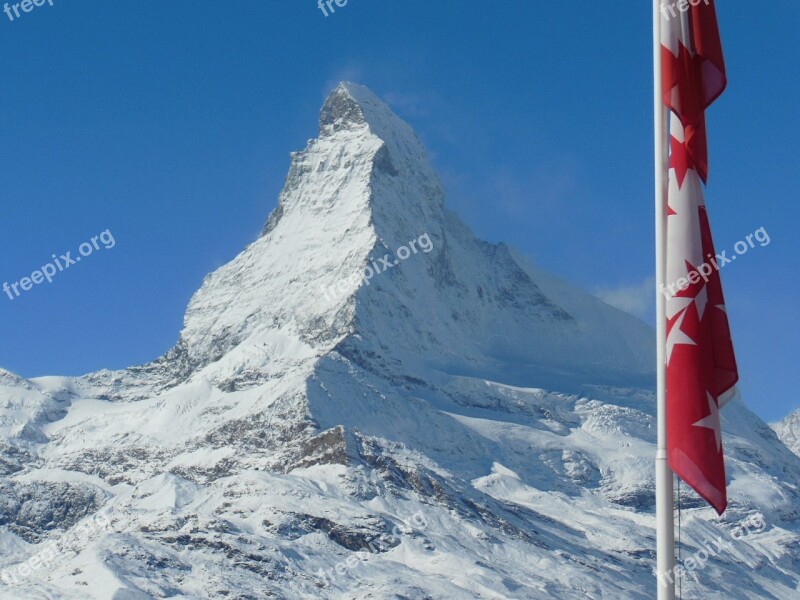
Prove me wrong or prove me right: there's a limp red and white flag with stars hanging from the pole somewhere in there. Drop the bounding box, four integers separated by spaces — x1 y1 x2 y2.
659 0 739 514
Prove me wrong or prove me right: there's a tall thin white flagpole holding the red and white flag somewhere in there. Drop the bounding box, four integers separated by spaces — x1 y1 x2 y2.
653 0 675 600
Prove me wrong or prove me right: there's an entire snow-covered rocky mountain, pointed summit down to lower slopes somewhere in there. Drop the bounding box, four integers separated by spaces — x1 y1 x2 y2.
0 83 800 600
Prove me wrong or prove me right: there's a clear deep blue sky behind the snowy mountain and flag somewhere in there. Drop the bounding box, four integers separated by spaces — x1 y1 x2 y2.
0 0 800 420
